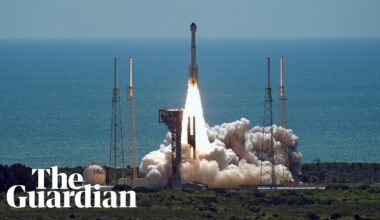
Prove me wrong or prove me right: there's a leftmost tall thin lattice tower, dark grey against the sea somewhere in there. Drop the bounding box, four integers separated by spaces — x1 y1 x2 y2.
109 58 125 172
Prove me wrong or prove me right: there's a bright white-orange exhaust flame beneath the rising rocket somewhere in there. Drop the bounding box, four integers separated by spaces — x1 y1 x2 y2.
181 83 210 155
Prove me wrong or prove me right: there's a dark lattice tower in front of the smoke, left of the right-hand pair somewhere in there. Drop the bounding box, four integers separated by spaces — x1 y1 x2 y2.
260 57 276 185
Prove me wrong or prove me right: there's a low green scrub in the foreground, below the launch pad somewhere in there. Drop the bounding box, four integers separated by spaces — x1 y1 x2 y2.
0 187 380 219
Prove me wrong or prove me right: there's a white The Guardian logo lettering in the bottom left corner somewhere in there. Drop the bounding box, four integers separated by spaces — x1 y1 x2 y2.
7 166 137 208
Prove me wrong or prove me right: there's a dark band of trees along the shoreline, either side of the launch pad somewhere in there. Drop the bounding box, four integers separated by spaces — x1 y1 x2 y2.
0 162 380 192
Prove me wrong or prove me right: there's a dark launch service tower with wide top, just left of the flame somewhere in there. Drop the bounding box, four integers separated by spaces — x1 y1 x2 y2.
158 109 183 188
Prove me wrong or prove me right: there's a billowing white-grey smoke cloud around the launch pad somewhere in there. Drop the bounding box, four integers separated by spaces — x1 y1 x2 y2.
140 118 302 188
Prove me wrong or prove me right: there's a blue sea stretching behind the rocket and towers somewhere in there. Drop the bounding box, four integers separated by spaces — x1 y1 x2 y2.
0 38 380 167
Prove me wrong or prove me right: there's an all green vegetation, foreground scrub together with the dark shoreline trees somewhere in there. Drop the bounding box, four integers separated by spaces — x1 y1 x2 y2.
0 163 380 219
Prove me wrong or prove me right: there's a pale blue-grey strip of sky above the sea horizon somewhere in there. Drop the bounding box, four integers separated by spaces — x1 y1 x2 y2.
0 0 380 39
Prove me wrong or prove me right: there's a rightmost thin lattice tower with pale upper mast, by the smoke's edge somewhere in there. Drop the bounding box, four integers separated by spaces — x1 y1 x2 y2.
278 56 289 181
